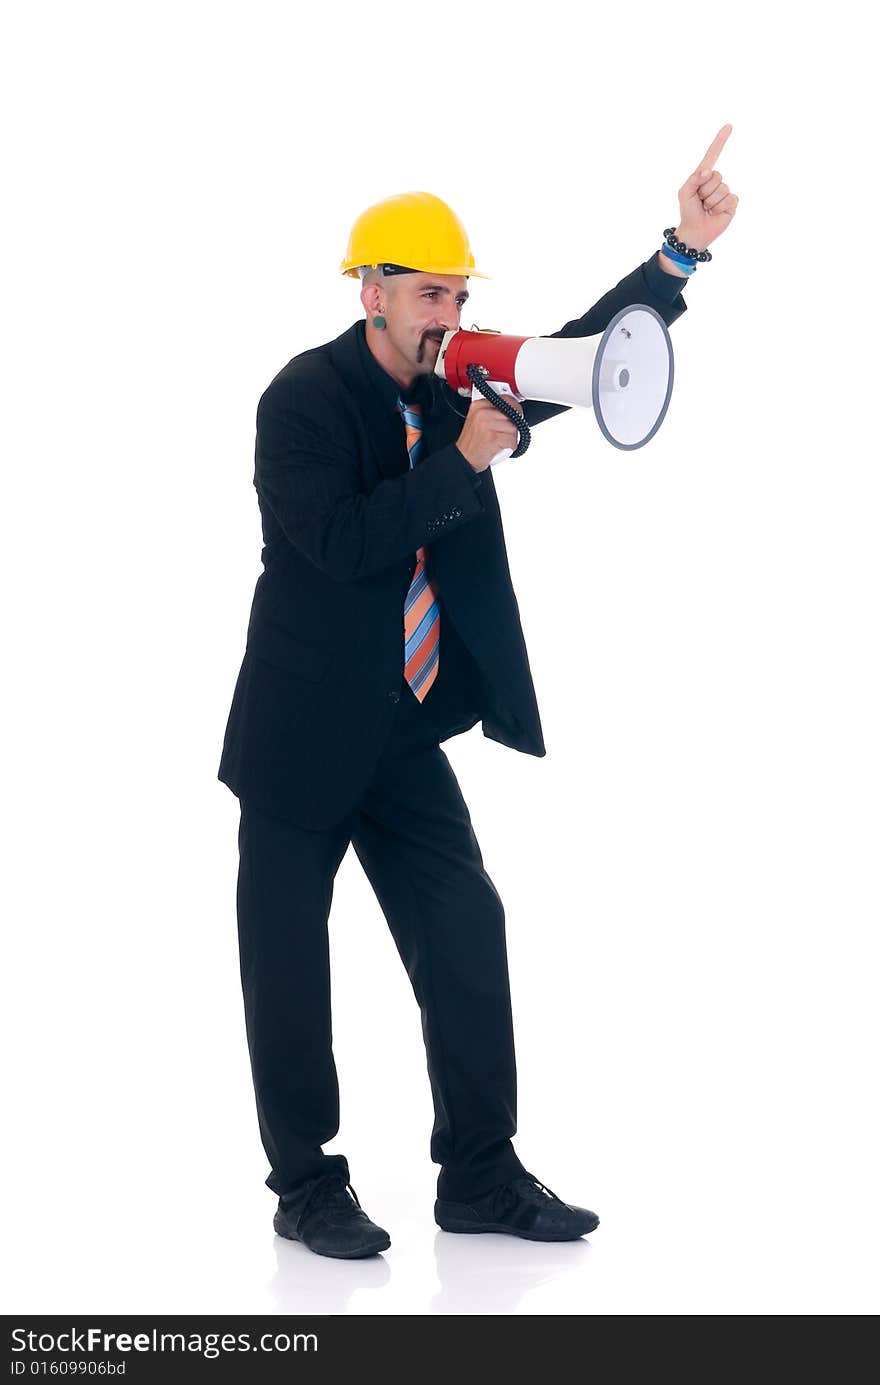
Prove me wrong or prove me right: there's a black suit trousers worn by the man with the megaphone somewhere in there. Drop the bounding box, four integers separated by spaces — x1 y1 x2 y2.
237 683 525 1201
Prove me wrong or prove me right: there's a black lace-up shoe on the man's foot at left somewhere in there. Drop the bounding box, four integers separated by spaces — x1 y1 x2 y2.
273 1173 391 1260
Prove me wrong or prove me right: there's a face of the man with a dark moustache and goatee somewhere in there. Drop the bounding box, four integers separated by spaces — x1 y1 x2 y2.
382 271 468 375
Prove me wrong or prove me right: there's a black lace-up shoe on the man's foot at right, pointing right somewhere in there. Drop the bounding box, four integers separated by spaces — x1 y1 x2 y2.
434 1173 599 1241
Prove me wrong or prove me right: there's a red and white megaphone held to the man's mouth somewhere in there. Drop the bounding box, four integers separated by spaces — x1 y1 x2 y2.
434 303 674 467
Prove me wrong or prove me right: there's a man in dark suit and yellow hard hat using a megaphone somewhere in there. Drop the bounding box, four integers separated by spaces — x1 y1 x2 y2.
219 193 698 1258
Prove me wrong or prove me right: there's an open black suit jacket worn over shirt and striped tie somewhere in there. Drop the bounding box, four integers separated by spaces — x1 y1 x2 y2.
218 252 686 830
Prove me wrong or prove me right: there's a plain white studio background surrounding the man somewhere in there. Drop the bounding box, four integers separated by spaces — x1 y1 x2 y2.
0 0 880 1314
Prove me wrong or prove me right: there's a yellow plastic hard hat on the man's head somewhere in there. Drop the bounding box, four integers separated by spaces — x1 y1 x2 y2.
340 193 489 278
